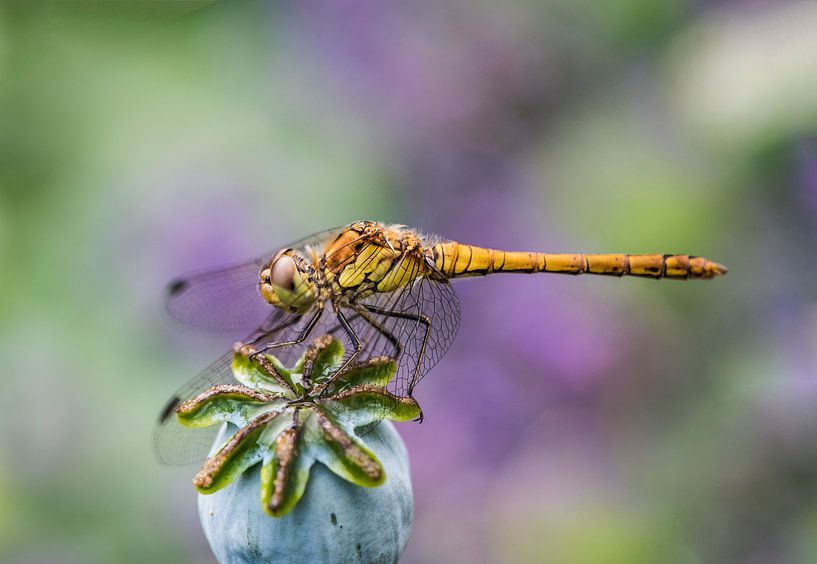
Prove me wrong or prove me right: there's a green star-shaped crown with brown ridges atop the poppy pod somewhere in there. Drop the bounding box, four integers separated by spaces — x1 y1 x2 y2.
176 335 421 517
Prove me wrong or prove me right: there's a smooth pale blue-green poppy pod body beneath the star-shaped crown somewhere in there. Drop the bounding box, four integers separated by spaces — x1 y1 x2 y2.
198 421 413 564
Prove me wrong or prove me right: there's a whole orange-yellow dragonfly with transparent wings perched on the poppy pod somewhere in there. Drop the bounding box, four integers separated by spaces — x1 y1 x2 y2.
154 221 727 464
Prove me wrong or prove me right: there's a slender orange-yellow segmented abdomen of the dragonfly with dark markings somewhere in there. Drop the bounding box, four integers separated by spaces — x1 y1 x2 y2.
431 241 728 280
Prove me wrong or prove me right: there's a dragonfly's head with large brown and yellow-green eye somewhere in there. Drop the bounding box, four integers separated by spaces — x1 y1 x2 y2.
260 249 318 313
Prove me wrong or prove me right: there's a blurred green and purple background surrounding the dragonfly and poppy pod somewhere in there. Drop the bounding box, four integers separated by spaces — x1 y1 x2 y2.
0 0 817 563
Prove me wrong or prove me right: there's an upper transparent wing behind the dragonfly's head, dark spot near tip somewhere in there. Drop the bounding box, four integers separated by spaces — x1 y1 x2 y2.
166 228 342 331
